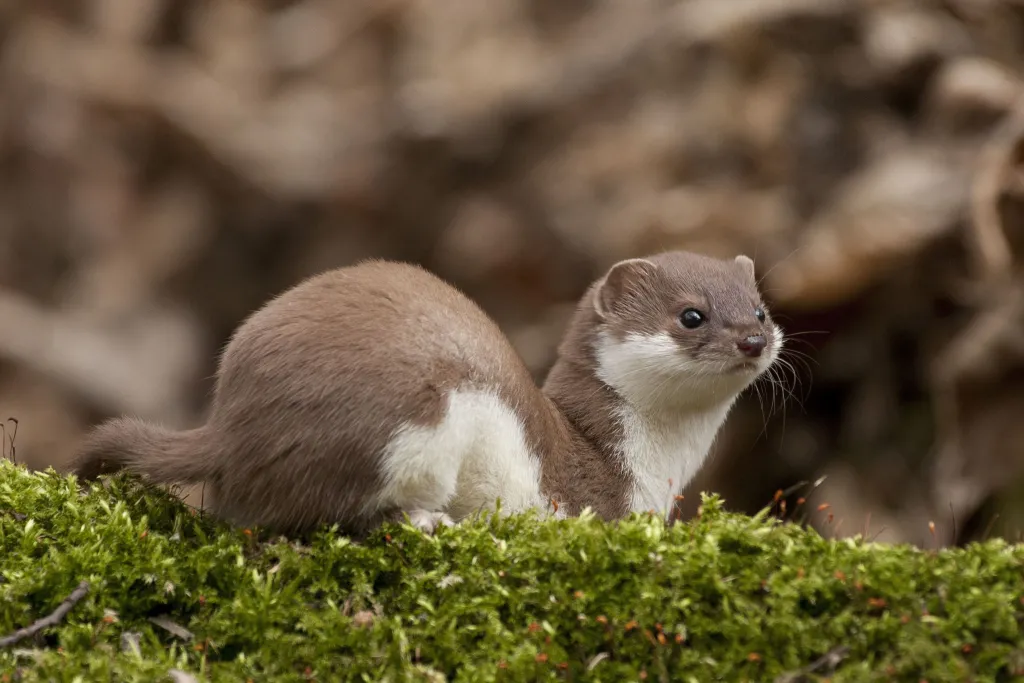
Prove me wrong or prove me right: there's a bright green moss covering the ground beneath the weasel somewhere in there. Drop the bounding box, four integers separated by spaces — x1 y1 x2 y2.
0 463 1024 683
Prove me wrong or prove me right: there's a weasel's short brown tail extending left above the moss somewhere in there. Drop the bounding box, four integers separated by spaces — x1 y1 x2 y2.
72 418 213 483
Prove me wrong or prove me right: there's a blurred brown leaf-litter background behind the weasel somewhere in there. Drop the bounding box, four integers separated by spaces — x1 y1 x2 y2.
0 0 1024 547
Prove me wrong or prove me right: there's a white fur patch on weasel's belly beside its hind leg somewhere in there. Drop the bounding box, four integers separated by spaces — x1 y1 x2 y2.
377 390 544 521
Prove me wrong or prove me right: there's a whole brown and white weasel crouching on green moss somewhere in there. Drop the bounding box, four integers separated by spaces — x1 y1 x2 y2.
73 251 783 533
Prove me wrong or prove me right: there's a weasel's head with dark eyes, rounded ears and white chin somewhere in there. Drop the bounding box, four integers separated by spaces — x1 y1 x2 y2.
585 252 782 405
